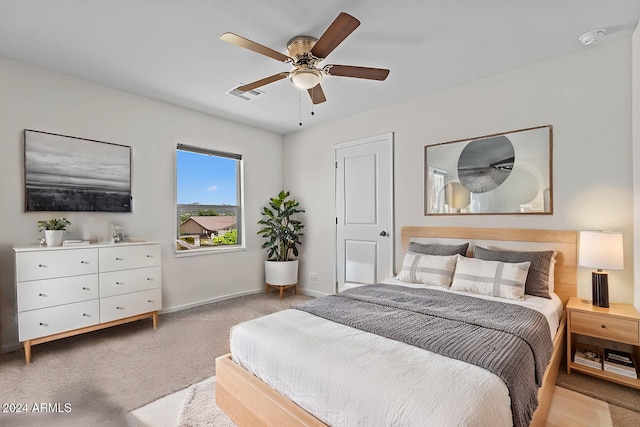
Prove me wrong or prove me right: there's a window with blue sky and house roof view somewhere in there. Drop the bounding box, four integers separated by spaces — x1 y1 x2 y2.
176 144 243 253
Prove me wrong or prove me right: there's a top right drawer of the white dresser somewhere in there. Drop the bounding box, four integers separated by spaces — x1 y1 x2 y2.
100 245 160 271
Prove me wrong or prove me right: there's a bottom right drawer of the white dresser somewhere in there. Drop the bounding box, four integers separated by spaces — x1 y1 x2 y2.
100 288 162 322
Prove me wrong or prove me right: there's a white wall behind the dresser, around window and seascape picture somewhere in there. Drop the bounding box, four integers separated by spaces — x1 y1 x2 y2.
0 58 283 350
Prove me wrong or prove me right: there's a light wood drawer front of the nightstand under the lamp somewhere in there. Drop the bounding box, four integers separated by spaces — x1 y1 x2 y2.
571 311 639 345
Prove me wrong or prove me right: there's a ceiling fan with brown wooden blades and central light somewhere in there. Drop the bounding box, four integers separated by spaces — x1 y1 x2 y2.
220 12 389 104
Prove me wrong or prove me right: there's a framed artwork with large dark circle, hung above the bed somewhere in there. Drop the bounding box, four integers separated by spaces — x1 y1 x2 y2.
424 125 553 215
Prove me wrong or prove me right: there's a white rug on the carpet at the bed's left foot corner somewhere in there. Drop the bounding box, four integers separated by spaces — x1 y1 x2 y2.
130 376 235 427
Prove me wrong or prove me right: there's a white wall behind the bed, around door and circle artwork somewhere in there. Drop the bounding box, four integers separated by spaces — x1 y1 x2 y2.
284 38 633 302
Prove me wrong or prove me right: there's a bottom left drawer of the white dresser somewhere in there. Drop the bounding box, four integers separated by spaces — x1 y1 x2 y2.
18 300 100 341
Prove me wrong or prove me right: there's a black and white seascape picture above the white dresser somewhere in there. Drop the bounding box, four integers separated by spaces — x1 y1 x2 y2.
24 129 131 212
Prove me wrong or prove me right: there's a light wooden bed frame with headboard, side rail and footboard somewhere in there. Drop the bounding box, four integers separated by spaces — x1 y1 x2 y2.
216 227 578 427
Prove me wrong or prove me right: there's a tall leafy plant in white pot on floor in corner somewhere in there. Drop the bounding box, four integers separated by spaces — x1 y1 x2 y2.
258 191 304 298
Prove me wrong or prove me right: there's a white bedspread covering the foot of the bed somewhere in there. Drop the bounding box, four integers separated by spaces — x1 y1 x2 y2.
231 284 562 427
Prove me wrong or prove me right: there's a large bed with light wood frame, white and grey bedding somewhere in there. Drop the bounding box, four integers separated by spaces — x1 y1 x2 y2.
216 227 577 426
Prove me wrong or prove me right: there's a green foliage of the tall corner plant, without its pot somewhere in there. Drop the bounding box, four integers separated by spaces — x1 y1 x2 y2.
258 190 304 261
